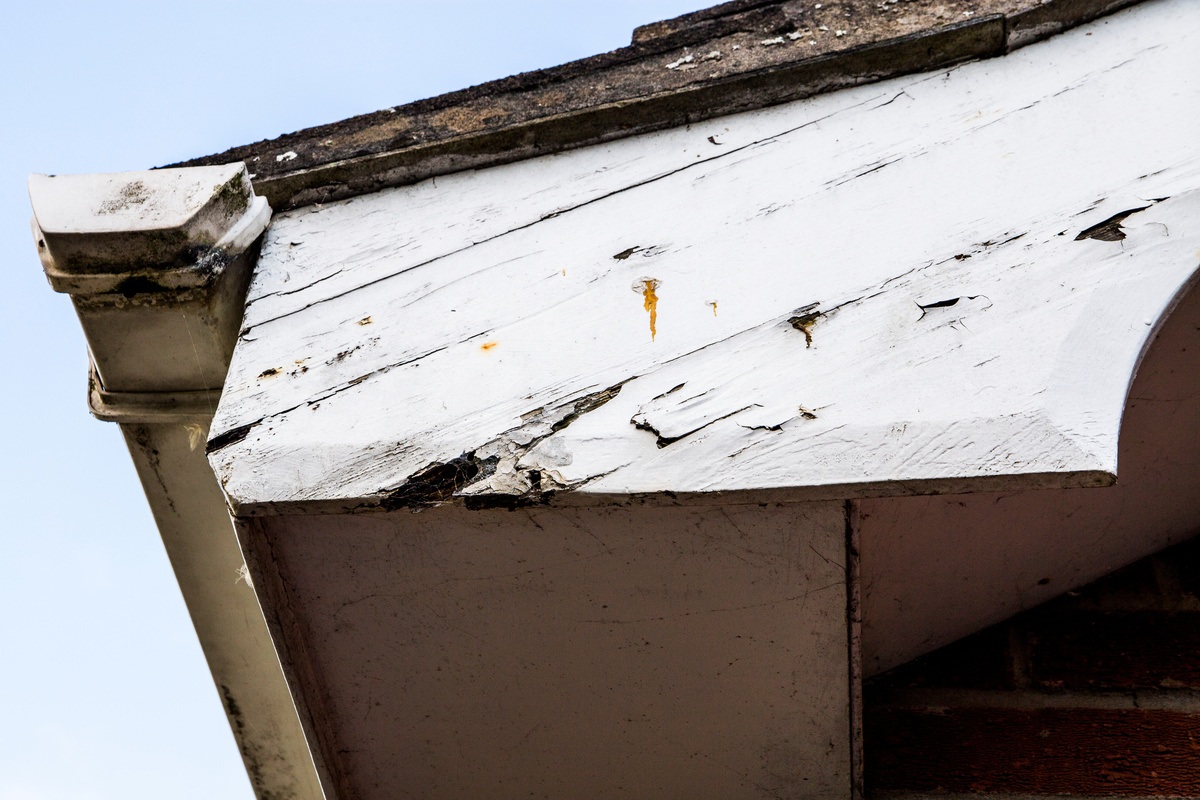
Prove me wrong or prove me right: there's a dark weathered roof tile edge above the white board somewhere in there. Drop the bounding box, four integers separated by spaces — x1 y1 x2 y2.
176 0 1138 210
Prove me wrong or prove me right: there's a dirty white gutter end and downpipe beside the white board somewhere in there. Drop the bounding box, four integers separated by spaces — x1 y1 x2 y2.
29 164 324 800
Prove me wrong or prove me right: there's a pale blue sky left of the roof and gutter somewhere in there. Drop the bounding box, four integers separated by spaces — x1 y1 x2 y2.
0 0 709 800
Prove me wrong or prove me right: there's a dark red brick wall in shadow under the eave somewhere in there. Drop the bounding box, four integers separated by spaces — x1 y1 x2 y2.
864 540 1200 798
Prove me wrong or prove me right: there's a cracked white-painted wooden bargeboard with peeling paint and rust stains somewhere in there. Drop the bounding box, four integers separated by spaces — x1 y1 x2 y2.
211 0 1200 513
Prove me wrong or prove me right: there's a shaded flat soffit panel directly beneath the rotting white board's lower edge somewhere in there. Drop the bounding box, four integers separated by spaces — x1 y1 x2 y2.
244 503 851 800
